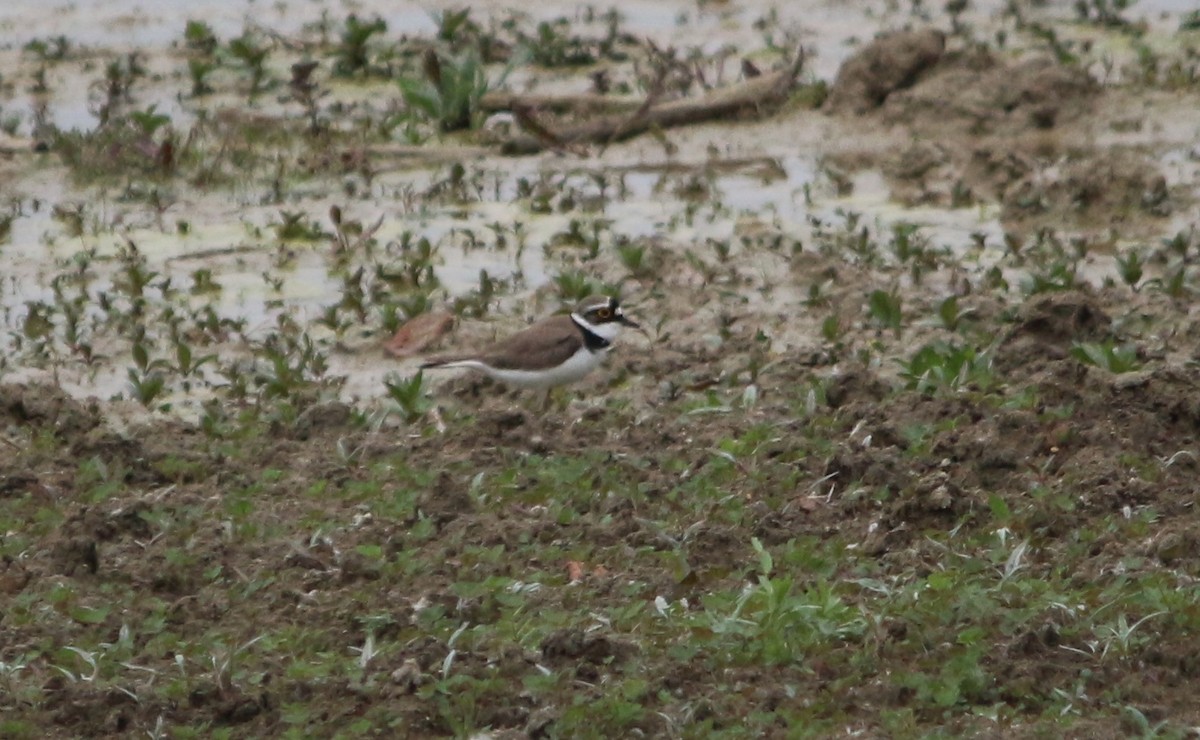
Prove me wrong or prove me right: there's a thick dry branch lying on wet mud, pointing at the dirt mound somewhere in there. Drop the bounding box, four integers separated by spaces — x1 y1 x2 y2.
500 50 804 155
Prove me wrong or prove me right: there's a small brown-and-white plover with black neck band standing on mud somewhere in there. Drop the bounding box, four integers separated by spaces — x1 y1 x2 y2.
421 295 641 392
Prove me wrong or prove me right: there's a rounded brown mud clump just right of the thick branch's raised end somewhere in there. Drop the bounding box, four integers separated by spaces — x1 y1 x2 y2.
826 29 946 115
